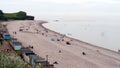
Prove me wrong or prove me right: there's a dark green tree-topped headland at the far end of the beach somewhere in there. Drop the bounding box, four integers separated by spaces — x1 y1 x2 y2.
0 10 34 21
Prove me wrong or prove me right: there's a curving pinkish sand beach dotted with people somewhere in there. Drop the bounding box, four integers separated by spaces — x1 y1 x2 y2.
7 20 120 68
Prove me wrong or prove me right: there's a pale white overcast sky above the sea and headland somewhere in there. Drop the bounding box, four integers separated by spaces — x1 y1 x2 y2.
0 0 120 17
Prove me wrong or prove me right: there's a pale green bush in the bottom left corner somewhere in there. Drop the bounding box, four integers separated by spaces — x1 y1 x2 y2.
0 52 27 68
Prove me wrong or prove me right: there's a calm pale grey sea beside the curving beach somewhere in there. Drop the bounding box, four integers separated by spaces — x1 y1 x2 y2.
41 16 120 51
